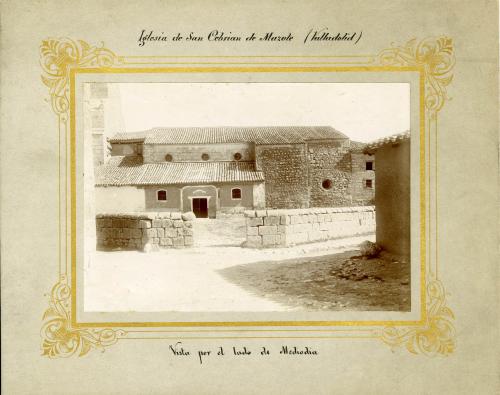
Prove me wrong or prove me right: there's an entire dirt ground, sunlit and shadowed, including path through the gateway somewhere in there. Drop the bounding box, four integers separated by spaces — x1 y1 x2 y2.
84 216 410 311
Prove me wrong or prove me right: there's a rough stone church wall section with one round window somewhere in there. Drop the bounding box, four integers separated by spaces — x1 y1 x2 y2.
307 140 352 207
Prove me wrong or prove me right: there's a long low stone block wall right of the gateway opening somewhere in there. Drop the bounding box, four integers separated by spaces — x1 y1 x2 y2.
245 206 375 248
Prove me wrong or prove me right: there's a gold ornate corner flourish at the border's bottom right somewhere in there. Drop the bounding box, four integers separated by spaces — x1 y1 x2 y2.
380 280 456 356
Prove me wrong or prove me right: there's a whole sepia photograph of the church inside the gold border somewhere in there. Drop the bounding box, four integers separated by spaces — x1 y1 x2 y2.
82 82 411 312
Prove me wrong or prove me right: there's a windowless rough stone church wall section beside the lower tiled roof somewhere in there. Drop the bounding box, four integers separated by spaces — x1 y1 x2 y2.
255 144 309 208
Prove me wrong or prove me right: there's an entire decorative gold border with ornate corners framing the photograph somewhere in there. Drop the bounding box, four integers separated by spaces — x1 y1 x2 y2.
40 37 455 358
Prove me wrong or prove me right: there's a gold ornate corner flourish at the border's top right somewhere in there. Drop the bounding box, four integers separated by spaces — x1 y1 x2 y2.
378 36 455 118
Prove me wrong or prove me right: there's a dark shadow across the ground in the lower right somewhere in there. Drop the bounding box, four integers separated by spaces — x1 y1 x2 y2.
218 251 411 311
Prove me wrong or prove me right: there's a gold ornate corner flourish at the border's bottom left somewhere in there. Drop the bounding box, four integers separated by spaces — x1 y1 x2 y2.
40 276 126 358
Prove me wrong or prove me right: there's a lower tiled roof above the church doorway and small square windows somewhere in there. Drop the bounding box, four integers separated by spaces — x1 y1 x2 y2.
95 156 264 186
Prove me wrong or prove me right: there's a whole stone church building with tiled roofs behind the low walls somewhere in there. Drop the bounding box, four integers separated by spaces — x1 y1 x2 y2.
95 126 375 218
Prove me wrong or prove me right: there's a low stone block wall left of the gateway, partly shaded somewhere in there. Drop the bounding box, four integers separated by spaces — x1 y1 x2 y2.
96 212 195 251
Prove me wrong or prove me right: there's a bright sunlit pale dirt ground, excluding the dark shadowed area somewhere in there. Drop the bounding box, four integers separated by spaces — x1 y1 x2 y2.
84 235 382 311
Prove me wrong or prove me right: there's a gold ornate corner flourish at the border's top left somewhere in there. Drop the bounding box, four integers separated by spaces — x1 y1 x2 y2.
40 38 120 116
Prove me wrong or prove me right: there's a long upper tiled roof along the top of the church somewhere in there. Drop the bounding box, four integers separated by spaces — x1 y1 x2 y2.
109 126 347 144
